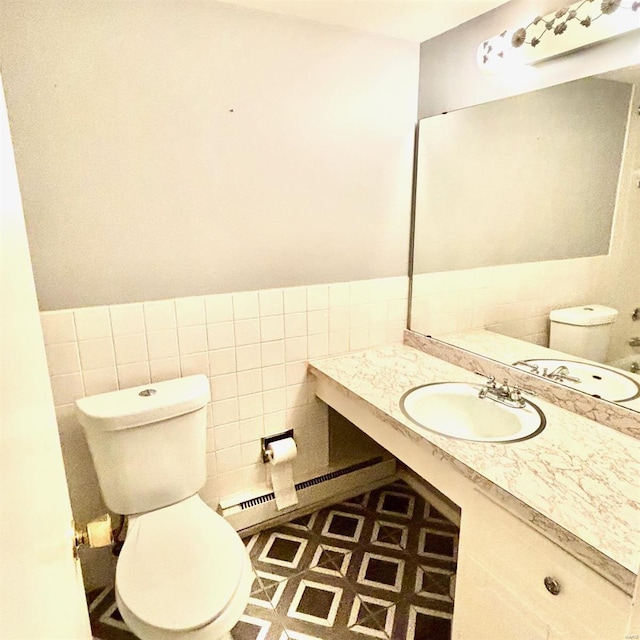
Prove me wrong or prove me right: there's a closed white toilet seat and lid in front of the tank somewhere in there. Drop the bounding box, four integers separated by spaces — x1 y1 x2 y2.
116 495 247 632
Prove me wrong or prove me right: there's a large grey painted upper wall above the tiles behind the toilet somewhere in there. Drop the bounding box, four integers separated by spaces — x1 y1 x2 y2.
0 0 419 310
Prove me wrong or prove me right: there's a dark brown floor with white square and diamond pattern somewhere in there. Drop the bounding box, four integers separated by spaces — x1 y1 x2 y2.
87 481 458 640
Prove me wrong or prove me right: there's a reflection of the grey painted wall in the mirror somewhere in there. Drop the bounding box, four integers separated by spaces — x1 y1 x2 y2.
414 78 632 273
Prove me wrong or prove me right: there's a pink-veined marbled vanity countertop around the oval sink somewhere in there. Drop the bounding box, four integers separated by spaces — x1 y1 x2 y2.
309 345 640 590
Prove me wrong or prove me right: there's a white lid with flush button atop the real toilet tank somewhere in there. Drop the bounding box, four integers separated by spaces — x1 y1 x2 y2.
76 374 210 431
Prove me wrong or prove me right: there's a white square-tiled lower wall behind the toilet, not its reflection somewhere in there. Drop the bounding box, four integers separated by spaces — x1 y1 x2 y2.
41 277 408 521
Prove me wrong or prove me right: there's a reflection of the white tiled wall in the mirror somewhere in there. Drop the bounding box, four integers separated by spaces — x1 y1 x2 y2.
412 256 608 346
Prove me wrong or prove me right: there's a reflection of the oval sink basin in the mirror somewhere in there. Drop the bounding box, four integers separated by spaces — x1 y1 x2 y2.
514 358 640 402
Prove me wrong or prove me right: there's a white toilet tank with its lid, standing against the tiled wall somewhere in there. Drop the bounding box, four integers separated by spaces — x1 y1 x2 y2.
76 375 210 515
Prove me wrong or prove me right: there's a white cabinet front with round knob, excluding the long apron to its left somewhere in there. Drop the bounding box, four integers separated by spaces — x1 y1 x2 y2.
453 491 631 640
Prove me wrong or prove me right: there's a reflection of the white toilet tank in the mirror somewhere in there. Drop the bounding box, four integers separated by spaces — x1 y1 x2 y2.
549 304 618 362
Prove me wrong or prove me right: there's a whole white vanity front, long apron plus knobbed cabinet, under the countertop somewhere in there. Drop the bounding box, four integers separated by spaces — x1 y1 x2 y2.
316 370 637 640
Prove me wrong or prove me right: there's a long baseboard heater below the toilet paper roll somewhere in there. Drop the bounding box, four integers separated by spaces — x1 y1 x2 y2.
218 456 396 530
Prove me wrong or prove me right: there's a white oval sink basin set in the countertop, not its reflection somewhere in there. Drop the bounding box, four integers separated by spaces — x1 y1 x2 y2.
400 382 546 442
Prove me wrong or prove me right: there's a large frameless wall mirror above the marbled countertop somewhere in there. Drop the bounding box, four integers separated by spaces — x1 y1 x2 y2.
409 66 640 411
